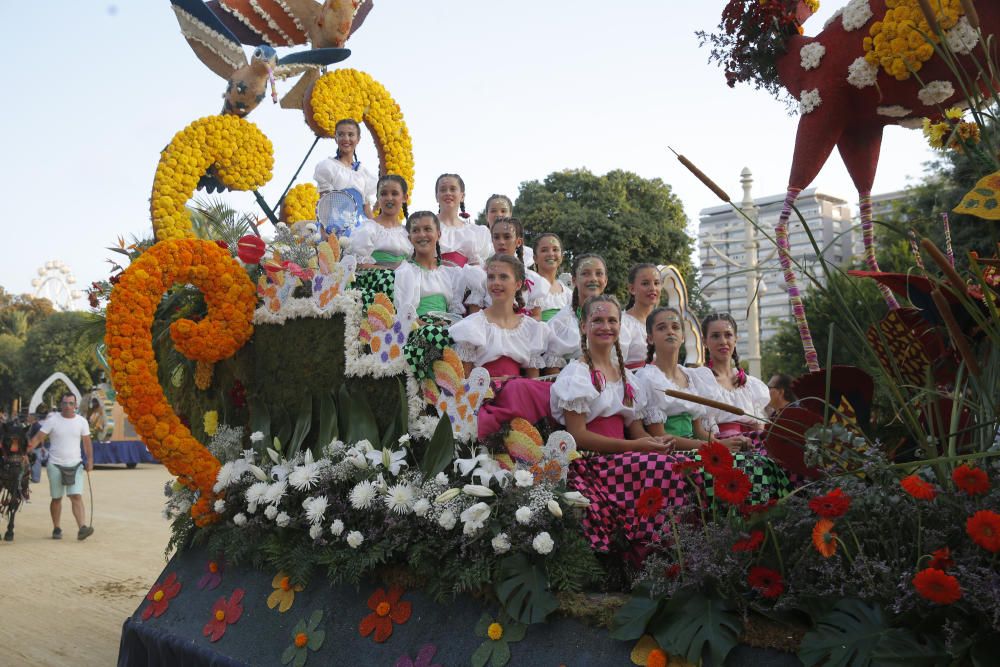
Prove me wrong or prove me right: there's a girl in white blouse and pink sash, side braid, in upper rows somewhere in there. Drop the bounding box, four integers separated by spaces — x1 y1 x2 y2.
434 174 493 266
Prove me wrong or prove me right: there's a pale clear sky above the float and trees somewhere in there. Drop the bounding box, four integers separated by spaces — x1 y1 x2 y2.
0 0 930 306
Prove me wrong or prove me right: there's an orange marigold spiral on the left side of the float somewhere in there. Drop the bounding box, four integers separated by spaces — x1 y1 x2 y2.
104 239 256 524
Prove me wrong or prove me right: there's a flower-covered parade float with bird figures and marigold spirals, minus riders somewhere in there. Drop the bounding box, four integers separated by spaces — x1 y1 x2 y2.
106 0 1000 667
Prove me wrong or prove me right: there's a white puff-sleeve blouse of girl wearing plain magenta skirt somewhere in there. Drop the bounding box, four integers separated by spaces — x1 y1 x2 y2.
449 311 548 368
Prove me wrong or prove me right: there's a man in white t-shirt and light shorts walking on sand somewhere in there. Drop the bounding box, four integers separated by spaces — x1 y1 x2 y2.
28 393 94 540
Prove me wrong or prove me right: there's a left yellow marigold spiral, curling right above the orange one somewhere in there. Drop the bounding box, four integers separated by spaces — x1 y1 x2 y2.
149 115 274 241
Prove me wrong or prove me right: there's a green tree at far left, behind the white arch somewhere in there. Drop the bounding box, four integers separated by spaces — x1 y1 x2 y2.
20 312 99 404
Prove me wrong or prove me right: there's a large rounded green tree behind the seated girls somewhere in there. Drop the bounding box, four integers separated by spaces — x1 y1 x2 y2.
514 169 694 298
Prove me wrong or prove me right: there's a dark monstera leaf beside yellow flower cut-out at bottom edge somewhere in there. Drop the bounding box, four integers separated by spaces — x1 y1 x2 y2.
649 591 743 665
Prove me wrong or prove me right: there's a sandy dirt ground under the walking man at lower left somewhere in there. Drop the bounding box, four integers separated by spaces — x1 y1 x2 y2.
0 464 170 667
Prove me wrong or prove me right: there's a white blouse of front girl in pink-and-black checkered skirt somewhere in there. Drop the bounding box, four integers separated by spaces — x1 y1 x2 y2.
549 361 645 426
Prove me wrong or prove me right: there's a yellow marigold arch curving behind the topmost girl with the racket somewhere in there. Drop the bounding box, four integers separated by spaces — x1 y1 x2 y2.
303 69 414 197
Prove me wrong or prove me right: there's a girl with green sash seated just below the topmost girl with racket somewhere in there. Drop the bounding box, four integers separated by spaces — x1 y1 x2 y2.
346 174 413 305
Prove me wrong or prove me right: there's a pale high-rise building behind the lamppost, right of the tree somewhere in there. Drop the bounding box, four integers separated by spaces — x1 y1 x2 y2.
698 188 861 357
